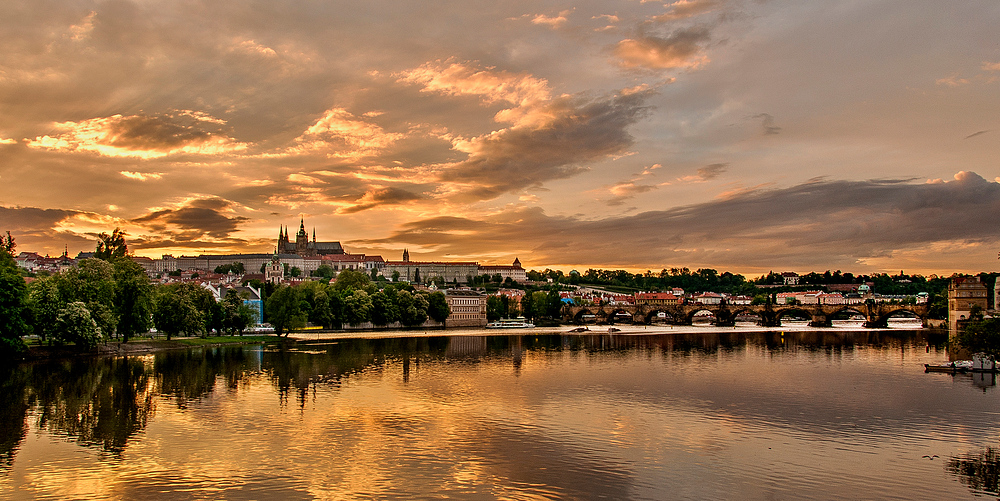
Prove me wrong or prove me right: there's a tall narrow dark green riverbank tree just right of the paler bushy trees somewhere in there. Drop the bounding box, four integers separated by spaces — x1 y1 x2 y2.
112 257 153 342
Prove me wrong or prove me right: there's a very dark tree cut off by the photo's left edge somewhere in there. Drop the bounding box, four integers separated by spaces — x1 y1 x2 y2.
0 232 31 354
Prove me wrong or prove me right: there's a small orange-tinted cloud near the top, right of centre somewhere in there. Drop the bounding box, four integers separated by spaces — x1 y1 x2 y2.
613 26 711 70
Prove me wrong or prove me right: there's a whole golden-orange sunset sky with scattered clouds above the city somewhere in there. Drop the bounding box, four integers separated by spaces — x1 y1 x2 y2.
0 0 1000 276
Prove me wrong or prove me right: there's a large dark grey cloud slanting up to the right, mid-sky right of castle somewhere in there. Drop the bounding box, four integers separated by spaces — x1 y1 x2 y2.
441 92 649 199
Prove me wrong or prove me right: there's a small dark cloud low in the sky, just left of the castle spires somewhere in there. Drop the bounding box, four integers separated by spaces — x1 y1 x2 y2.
131 198 249 240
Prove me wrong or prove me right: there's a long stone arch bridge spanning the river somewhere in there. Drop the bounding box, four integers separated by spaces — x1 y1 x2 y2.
562 302 928 328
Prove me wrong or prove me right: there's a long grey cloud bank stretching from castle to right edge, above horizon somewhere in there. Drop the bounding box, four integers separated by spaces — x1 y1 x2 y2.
368 172 1000 271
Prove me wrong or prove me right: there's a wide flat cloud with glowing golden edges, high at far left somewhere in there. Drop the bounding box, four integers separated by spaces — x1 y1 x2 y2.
27 110 247 158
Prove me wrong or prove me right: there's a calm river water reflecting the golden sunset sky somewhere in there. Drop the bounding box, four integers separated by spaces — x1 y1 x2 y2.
0 329 1000 500
